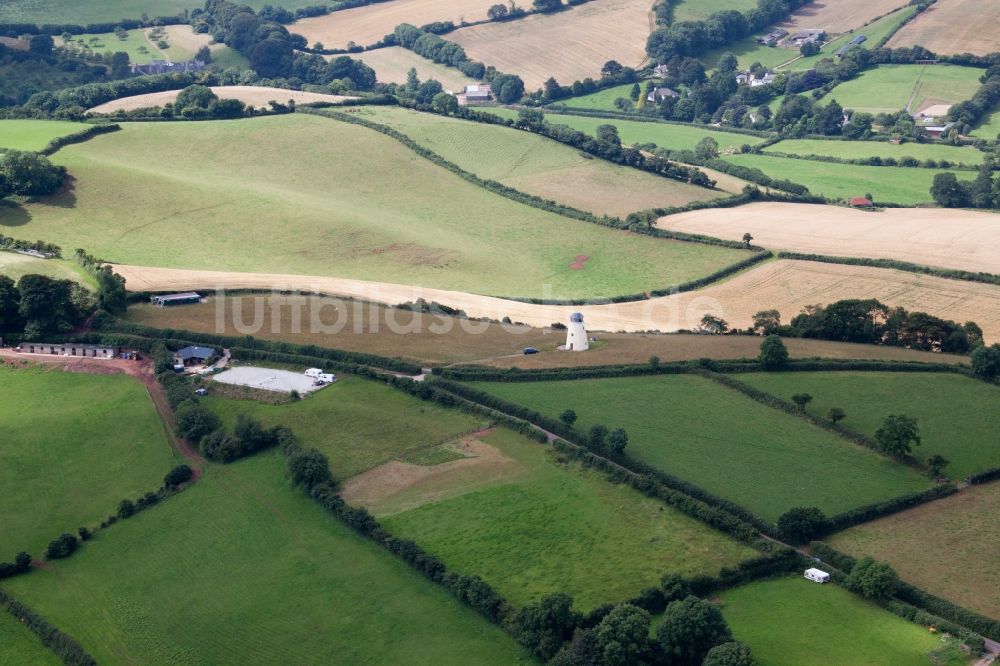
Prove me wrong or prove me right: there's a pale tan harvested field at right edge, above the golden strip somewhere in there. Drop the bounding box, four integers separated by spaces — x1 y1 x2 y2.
656 202 1000 273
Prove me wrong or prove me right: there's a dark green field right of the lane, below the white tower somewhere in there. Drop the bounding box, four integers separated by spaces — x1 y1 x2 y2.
473 375 929 521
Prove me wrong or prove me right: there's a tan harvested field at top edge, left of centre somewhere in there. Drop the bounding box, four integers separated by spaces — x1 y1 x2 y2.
289 0 496 48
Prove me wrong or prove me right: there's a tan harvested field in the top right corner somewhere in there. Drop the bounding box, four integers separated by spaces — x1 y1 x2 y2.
886 0 1000 55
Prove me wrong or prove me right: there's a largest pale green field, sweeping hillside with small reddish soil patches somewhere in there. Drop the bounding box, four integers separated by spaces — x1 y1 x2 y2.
0 114 747 298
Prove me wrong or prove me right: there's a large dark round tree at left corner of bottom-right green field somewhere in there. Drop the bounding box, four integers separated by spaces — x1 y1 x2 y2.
656 595 733 666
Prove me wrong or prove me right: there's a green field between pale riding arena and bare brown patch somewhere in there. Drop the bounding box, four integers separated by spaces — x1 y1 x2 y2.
205 377 484 480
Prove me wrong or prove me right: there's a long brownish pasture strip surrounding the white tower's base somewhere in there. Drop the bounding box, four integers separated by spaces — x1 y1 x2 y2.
127 294 968 368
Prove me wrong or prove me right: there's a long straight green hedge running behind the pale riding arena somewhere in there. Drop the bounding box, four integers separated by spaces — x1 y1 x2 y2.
94 320 421 375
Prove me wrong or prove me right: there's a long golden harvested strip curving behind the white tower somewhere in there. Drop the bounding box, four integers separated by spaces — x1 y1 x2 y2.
115 260 1000 342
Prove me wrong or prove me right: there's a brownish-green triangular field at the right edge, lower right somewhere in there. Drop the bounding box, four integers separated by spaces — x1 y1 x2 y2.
827 481 1000 618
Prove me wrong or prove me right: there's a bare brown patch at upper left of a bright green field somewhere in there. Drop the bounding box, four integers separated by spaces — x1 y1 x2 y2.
340 430 522 515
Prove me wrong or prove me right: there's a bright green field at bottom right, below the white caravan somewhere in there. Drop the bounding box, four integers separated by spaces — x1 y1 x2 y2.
720 576 965 666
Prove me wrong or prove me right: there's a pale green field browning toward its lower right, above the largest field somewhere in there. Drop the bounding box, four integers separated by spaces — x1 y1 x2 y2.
358 107 723 217
